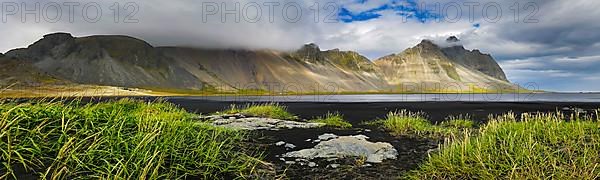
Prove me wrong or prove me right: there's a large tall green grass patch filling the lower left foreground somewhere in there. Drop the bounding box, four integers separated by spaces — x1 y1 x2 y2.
0 99 259 179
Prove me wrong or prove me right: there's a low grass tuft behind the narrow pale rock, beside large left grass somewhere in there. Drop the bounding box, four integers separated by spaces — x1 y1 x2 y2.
217 103 297 120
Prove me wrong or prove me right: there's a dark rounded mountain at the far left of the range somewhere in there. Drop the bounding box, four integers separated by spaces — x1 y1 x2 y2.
6 33 203 89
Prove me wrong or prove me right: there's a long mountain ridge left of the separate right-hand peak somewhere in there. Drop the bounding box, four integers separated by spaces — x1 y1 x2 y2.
7 33 387 92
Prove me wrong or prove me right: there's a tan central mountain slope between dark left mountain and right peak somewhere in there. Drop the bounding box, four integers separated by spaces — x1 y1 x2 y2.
160 45 386 92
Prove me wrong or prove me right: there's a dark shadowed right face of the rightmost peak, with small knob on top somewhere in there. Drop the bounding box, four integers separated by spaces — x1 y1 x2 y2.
442 36 508 82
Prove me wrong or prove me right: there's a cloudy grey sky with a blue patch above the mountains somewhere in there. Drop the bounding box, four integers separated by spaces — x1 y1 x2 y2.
0 0 600 92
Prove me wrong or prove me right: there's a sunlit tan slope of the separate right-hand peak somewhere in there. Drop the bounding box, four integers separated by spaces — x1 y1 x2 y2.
375 40 511 92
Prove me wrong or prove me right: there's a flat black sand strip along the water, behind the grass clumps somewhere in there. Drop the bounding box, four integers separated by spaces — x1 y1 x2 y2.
167 98 600 124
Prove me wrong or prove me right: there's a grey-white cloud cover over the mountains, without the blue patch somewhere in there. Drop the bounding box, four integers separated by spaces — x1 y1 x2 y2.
0 0 600 90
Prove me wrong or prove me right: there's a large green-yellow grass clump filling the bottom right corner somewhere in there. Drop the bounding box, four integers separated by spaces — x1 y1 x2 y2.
408 113 600 179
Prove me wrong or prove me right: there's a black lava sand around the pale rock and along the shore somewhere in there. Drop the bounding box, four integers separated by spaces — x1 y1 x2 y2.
163 99 600 179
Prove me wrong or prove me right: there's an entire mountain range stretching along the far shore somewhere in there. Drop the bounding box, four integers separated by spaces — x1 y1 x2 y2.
3 33 510 93
